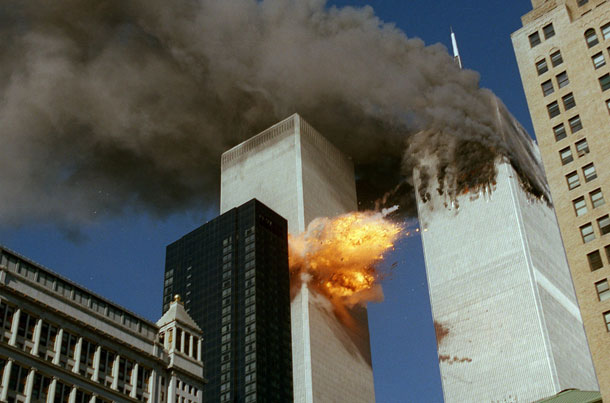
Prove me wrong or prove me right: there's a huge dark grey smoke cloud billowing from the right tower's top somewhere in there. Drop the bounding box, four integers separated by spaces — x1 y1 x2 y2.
0 0 545 226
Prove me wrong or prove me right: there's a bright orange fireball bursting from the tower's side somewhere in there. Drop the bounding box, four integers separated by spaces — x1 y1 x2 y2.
289 210 402 306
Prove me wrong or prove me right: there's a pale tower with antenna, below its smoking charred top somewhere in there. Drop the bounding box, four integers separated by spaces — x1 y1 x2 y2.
415 159 598 402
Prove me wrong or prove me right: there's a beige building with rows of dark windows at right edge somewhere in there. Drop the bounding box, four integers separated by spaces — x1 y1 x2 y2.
512 0 610 400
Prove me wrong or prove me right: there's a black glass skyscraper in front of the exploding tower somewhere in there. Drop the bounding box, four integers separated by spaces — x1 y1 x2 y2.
163 199 293 403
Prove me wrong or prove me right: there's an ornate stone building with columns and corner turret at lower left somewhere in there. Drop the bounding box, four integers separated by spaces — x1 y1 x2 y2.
0 246 204 403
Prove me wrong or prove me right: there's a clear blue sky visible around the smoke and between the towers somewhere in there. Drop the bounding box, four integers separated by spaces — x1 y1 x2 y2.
0 0 532 403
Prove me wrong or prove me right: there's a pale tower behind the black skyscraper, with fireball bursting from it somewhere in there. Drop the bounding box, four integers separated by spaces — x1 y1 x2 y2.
220 114 375 403
